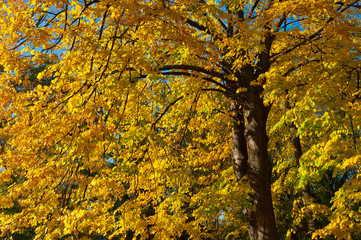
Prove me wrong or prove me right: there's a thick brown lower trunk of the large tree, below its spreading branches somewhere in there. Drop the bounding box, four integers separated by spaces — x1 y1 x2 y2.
232 86 278 240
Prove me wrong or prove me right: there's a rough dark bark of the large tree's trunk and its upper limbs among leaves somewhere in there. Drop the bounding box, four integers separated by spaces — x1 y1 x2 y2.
224 0 279 237
